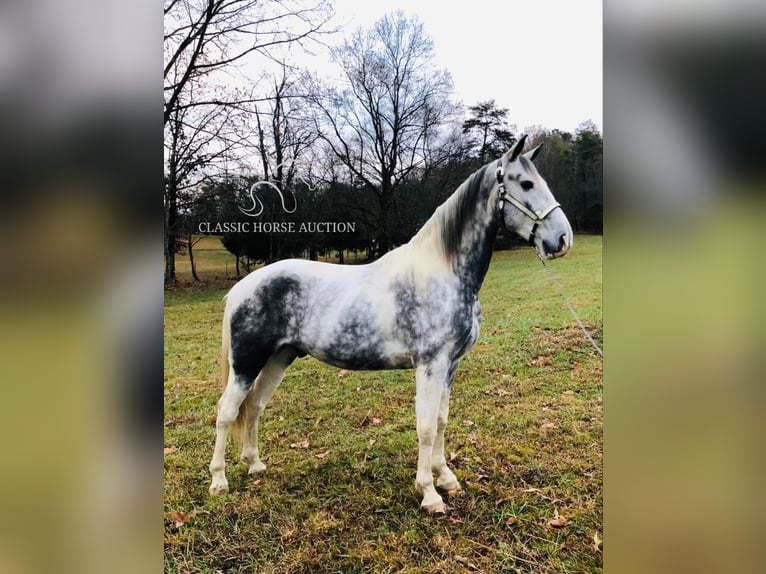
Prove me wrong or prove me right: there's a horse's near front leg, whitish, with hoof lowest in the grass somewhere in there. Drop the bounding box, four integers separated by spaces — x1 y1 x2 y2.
415 361 449 514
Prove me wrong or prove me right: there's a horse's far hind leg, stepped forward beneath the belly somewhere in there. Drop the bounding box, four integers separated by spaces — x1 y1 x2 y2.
240 347 297 475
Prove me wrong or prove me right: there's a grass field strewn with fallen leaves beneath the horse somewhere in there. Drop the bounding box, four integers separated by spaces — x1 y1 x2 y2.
165 236 602 573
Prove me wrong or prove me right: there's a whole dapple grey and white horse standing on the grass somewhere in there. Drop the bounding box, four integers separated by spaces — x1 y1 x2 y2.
210 137 573 513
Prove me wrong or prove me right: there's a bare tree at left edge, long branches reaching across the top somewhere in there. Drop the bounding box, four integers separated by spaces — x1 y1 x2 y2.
164 0 332 282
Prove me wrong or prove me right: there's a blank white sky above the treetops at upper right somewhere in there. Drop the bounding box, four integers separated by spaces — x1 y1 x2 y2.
320 0 602 131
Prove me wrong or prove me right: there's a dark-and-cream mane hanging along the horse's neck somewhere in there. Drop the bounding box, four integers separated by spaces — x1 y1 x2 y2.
410 165 487 259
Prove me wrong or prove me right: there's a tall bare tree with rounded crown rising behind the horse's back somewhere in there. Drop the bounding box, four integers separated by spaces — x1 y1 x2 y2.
315 12 452 254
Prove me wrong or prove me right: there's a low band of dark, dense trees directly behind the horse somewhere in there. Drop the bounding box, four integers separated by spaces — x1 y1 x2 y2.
180 125 602 275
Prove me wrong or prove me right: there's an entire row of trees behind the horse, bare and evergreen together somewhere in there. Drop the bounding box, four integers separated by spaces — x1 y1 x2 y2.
164 0 602 281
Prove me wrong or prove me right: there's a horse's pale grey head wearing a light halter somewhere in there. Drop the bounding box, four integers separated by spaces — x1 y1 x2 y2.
495 136 574 259
